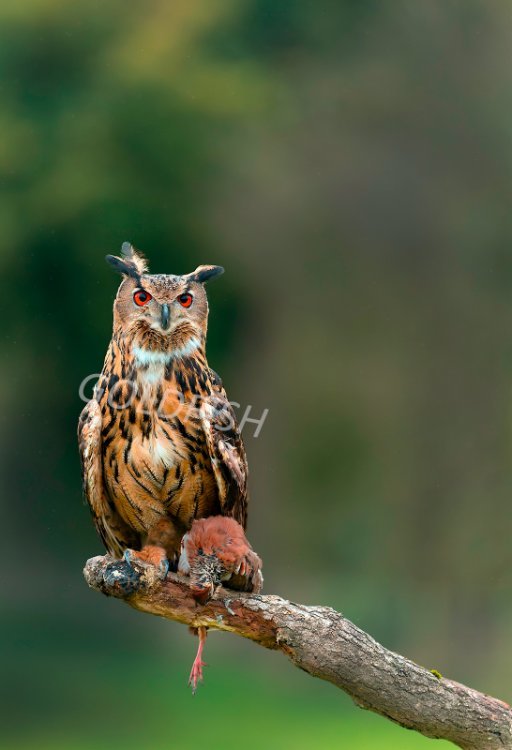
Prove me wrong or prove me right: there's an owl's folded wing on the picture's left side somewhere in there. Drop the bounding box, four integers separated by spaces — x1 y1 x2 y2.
78 399 137 557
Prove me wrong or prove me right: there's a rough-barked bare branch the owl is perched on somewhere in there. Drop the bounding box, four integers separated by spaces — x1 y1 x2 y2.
84 557 512 750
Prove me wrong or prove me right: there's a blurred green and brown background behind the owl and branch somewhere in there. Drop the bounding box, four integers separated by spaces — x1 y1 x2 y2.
0 0 512 750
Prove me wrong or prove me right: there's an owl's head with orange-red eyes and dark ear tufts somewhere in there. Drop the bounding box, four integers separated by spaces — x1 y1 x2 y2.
106 242 224 354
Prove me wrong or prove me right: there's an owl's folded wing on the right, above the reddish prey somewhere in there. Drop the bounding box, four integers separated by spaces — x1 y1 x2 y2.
200 371 248 528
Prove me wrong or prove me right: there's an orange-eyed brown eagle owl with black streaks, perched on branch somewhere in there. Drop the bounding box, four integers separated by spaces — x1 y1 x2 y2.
78 243 247 575
